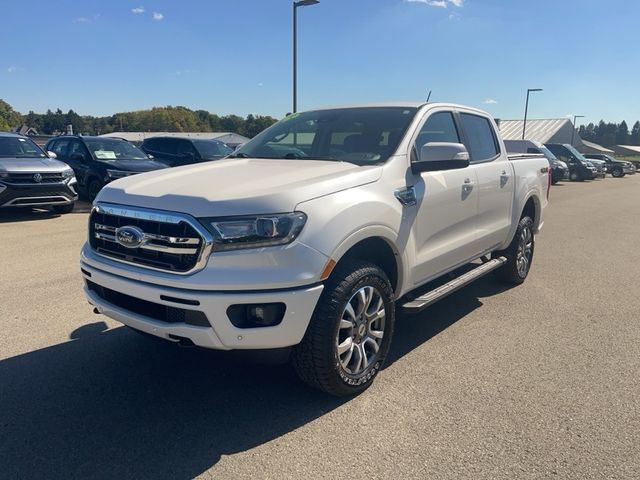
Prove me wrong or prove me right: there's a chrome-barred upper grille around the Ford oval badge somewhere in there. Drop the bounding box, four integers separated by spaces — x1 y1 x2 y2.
89 208 204 273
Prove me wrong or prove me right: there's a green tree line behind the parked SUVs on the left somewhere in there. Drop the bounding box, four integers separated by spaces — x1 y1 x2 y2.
0 100 277 138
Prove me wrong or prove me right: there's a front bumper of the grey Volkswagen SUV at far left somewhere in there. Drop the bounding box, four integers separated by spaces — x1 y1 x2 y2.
0 179 78 207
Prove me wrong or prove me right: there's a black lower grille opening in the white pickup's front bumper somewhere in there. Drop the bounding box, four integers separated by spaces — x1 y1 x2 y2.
85 280 211 327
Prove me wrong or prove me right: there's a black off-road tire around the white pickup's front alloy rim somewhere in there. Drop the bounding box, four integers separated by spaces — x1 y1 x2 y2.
291 260 395 397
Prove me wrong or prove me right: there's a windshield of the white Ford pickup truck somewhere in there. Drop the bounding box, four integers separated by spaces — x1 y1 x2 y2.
233 107 417 165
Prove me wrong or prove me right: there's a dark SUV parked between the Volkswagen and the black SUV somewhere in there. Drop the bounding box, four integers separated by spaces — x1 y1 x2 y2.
45 135 167 201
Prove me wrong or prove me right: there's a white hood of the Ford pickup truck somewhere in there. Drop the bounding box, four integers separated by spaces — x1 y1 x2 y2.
96 158 382 217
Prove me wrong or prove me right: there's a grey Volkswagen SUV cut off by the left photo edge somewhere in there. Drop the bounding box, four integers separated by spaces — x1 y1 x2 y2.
0 132 78 213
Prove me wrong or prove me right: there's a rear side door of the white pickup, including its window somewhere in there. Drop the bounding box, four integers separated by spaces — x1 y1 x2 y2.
459 111 515 252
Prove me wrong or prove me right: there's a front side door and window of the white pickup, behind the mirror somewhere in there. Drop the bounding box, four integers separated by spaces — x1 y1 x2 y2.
412 109 478 285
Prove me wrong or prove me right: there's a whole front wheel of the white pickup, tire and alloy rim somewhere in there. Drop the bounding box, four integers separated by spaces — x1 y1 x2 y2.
291 260 395 397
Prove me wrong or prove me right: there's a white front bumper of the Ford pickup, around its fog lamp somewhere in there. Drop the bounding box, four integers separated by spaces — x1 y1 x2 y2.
81 262 324 350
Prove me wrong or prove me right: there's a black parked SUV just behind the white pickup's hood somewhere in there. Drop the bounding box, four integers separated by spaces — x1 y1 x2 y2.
140 137 233 167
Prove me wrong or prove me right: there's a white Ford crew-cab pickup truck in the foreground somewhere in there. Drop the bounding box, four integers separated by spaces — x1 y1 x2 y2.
81 103 549 395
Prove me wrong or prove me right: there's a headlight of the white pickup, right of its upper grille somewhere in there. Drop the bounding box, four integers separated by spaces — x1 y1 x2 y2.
200 212 307 252
